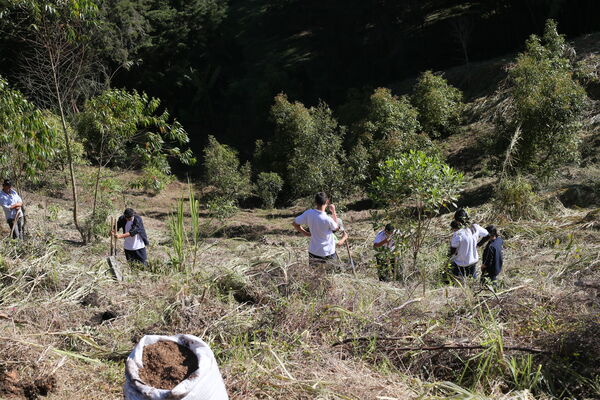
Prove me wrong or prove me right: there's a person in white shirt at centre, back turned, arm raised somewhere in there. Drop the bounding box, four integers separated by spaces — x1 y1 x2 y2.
292 192 340 266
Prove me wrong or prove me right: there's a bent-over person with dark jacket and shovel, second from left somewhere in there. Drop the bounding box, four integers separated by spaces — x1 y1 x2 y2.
111 208 149 265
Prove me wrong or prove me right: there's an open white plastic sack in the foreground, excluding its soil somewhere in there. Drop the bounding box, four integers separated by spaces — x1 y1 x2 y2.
123 335 229 400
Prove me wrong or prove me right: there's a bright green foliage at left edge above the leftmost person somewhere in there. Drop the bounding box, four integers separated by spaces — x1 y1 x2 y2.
0 77 59 185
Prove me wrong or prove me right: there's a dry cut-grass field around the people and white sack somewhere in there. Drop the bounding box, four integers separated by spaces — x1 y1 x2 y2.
0 153 600 399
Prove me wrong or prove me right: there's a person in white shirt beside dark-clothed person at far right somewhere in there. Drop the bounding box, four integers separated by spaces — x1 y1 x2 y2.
450 208 489 278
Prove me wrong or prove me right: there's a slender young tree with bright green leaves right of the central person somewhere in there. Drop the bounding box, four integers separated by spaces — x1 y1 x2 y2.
372 150 463 291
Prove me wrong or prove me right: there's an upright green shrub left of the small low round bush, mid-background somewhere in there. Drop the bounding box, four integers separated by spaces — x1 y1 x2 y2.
204 136 252 204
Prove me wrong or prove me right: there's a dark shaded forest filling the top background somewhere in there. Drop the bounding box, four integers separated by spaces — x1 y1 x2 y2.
0 0 600 163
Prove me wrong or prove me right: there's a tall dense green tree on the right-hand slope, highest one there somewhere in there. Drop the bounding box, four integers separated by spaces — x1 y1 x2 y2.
502 20 587 178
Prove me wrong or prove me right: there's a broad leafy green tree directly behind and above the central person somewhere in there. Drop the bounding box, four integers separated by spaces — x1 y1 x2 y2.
268 94 347 197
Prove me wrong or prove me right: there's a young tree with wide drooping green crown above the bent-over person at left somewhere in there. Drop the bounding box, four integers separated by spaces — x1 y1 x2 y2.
77 89 195 241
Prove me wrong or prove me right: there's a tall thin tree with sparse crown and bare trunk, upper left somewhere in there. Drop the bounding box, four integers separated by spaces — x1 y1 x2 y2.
0 0 98 236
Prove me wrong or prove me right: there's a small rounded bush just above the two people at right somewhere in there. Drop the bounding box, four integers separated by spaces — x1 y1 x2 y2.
494 176 540 219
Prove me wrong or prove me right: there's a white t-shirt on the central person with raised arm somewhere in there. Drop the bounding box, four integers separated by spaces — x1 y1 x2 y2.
294 208 338 257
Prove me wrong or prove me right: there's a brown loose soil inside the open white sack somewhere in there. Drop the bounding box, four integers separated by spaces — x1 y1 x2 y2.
140 342 198 390
